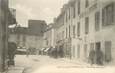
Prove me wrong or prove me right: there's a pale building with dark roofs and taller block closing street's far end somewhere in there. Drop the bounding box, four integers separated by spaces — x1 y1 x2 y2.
9 20 46 52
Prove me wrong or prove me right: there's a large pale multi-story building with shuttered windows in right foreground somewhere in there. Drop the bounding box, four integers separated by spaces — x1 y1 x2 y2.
54 0 115 62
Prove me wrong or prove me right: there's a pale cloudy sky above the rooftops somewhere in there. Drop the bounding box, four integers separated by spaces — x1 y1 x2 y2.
9 0 68 27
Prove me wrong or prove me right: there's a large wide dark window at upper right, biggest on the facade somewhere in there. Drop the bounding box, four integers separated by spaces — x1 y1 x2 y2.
102 3 114 26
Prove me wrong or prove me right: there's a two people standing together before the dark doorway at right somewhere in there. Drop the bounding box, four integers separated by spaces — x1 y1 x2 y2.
89 49 104 65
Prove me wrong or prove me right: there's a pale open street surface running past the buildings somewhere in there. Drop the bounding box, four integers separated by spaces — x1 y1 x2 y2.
15 55 115 73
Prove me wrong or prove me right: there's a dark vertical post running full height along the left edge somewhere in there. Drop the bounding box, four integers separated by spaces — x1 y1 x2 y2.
0 0 9 72
